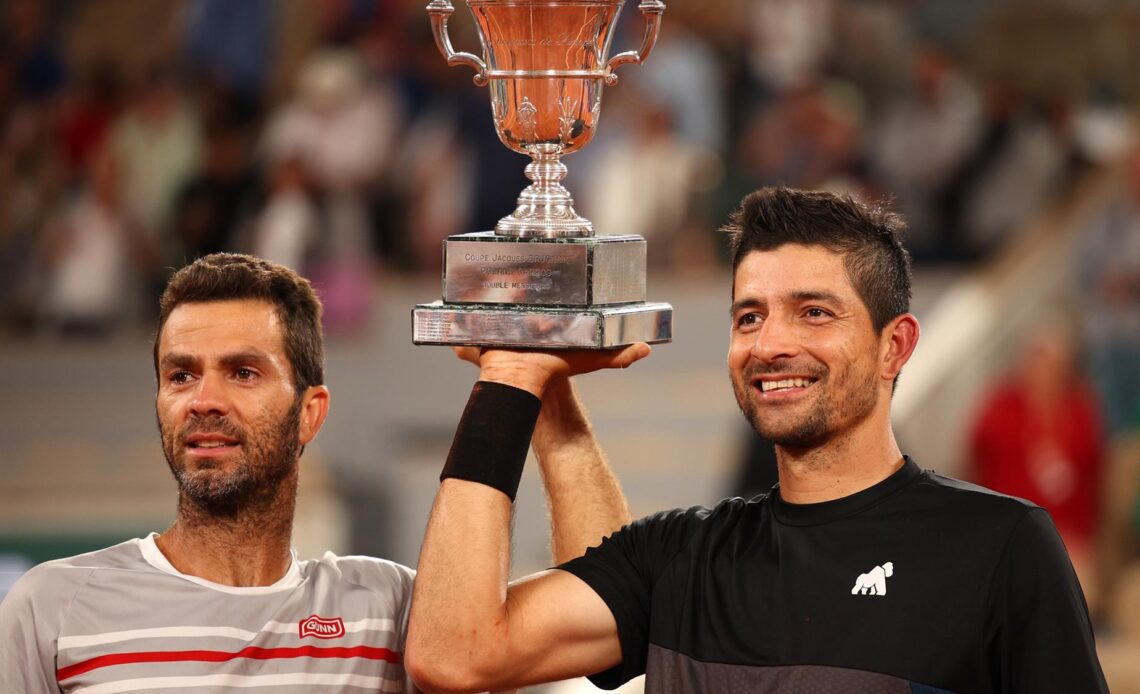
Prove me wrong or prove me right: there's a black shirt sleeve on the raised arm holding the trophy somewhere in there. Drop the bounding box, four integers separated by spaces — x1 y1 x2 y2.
559 507 708 689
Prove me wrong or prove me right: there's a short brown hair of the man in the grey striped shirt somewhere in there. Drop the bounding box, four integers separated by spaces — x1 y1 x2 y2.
154 253 325 393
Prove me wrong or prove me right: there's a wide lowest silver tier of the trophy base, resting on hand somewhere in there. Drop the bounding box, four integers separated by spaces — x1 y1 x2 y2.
412 301 673 350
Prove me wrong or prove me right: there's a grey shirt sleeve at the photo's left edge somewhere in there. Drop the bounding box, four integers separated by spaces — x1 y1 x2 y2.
0 568 65 694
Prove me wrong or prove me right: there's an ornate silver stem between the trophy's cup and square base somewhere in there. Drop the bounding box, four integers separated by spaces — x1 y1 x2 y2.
495 145 594 238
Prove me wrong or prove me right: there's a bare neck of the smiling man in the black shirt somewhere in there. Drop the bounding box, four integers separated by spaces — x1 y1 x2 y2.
776 417 904 504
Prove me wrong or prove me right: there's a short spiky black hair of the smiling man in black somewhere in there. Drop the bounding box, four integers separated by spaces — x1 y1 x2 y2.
723 188 911 332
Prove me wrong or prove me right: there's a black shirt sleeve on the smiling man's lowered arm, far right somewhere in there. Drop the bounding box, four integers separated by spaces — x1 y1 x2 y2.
990 507 1108 693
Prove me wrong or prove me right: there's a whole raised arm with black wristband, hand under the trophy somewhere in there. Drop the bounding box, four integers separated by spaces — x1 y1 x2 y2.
405 345 649 692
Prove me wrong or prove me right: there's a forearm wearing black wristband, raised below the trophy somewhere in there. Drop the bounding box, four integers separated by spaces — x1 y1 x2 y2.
406 383 539 691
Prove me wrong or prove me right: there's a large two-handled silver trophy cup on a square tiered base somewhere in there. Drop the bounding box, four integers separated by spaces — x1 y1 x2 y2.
412 0 673 349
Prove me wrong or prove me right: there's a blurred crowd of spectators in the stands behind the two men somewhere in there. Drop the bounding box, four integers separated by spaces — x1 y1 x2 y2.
0 0 1140 665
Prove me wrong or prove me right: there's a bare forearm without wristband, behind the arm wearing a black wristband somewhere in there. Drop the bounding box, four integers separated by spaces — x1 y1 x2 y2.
531 378 630 564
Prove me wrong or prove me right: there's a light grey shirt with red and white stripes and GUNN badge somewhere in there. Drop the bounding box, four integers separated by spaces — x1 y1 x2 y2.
0 534 415 694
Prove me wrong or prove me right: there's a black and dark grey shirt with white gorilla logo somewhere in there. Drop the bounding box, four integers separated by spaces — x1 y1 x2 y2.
561 459 1107 694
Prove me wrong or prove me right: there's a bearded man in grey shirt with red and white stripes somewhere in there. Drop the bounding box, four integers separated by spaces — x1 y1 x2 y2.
0 254 628 694
